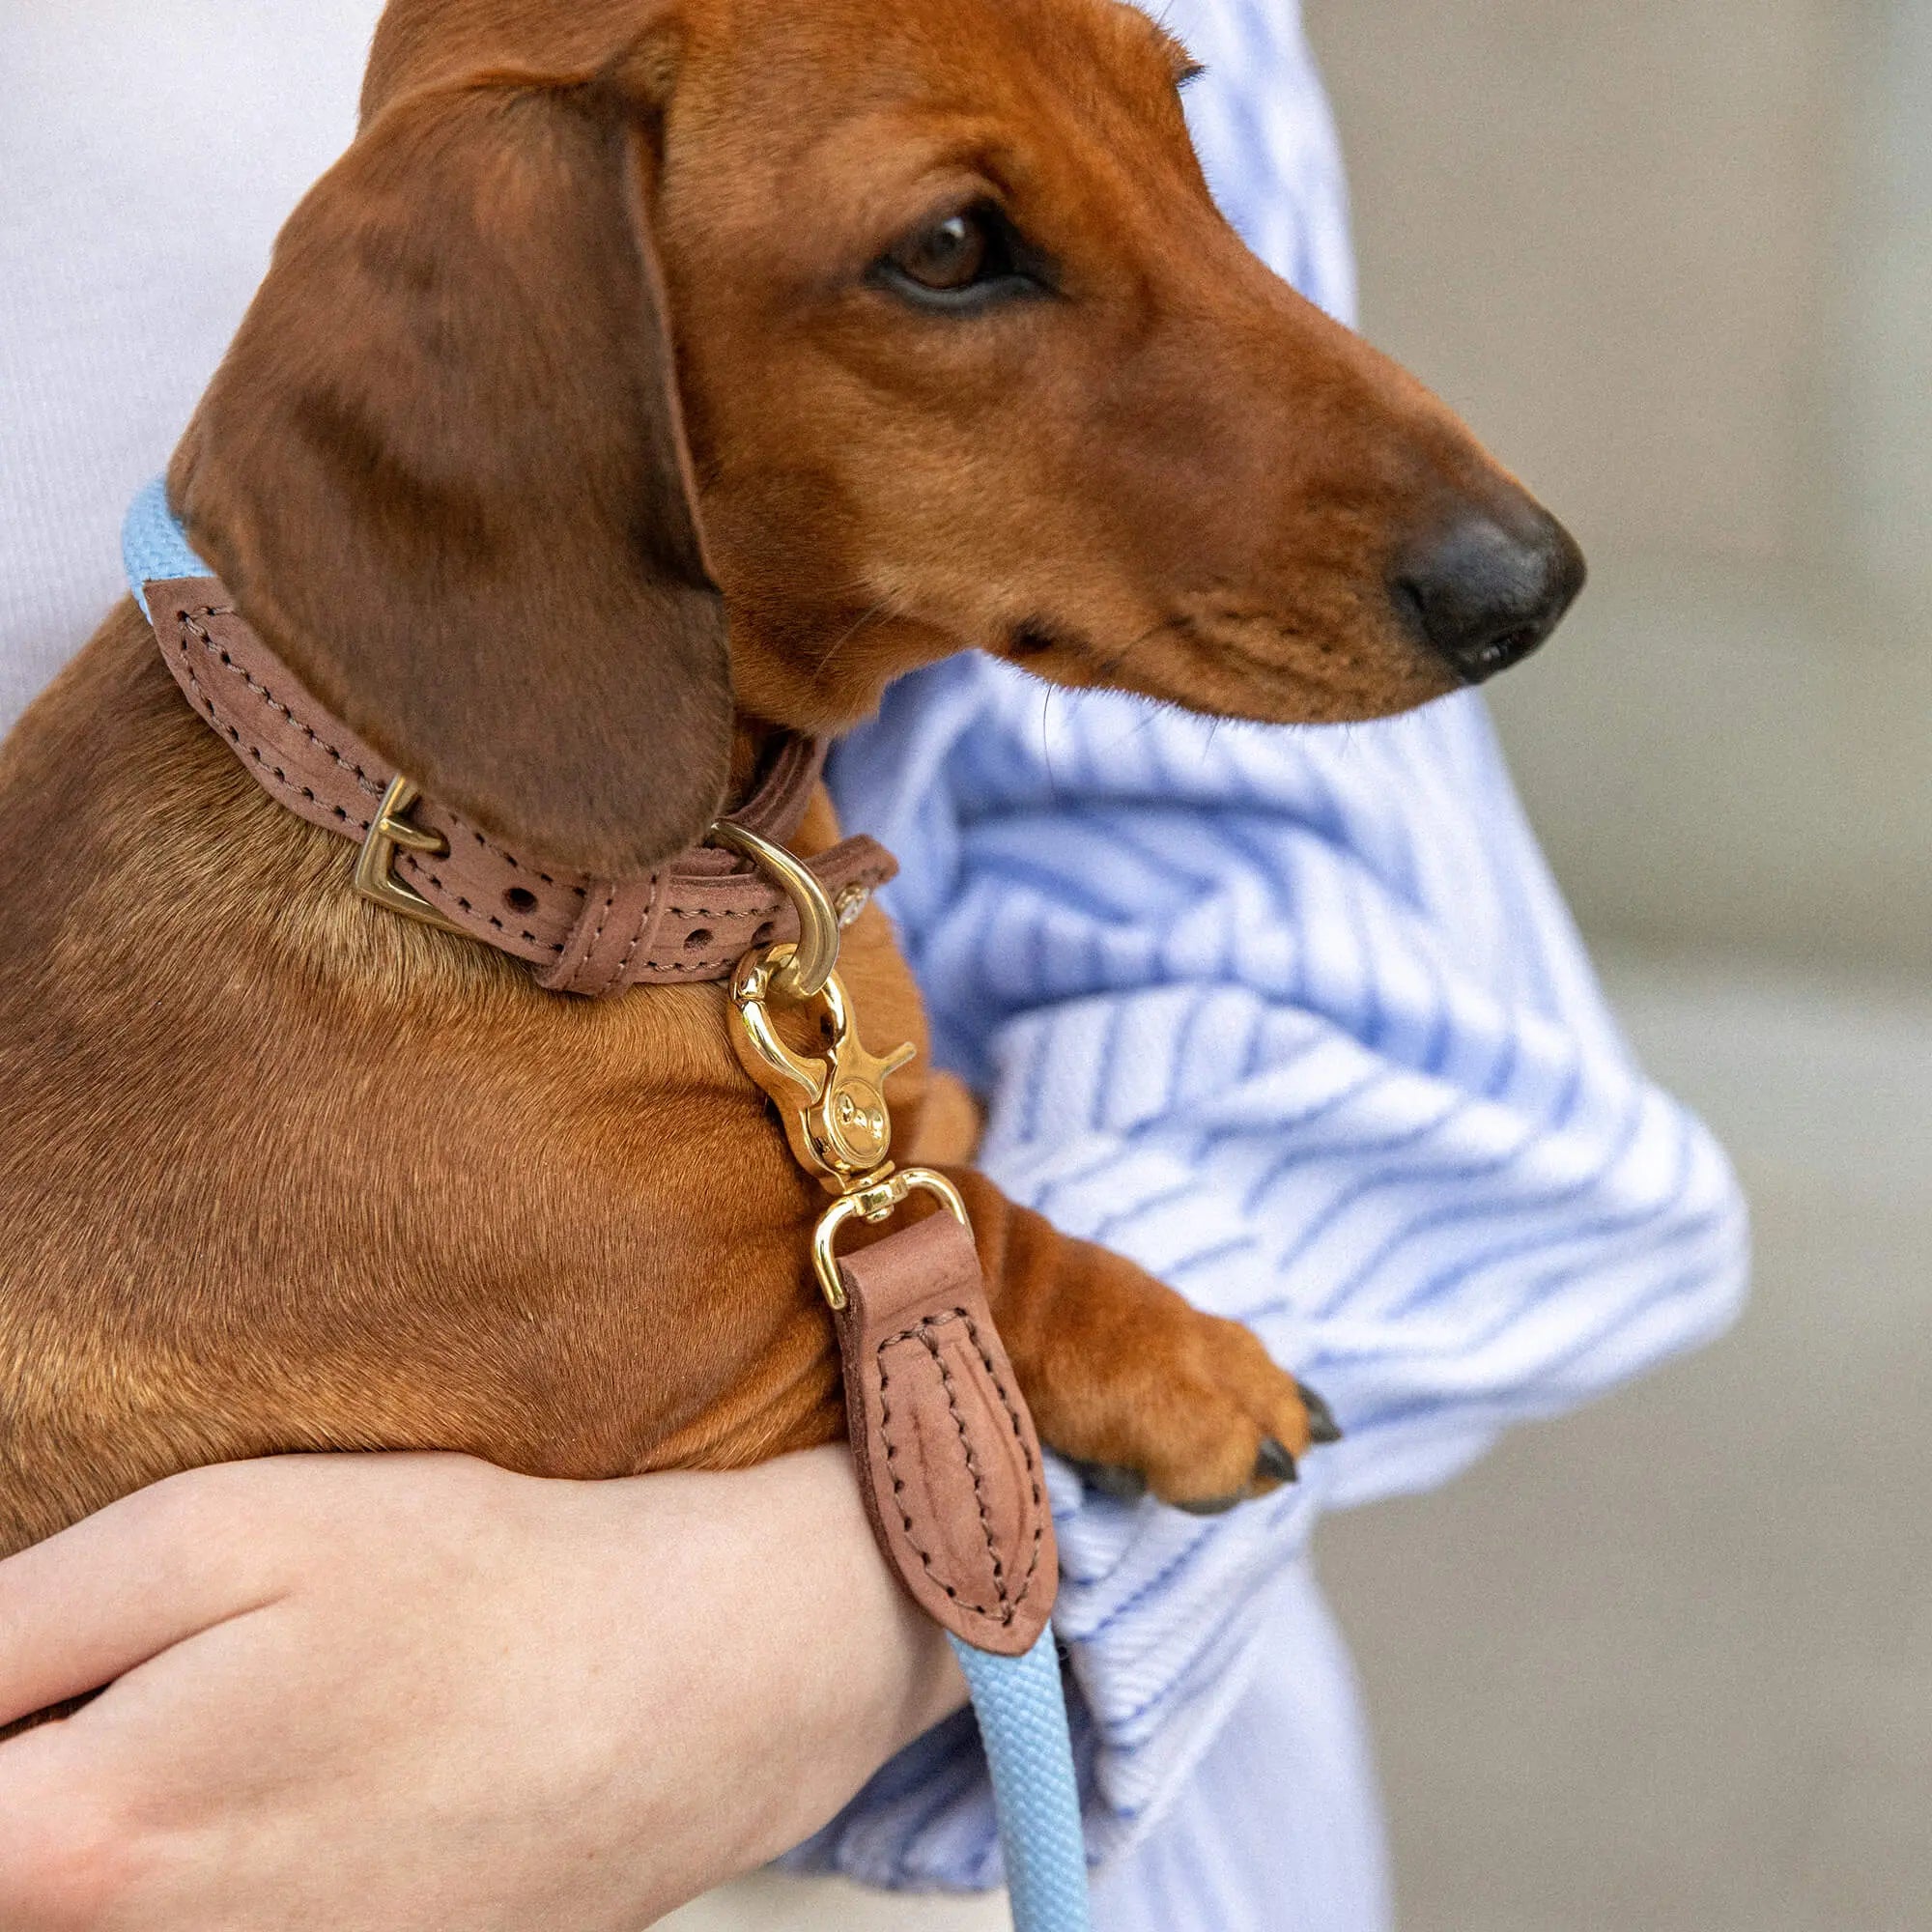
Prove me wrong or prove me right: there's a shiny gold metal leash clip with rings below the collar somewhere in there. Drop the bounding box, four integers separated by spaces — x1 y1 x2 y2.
711 823 968 1308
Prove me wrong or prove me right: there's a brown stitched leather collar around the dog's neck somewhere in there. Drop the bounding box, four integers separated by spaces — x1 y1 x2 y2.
147 578 896 997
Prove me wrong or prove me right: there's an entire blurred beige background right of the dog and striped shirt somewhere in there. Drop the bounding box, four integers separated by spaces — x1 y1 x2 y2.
1306 0 1932 1932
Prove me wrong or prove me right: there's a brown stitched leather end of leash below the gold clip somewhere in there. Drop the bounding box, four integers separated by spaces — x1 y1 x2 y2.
838 1213 1061 1658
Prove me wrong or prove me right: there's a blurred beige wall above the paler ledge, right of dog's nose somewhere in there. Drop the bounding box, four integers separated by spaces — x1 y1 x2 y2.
1308 0 1932 974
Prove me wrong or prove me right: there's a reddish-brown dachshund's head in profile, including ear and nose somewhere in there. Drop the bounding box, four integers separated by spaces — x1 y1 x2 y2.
172 0 1582 875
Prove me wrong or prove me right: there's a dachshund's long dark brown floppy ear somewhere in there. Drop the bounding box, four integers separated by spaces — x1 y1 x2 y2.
170 77 730 877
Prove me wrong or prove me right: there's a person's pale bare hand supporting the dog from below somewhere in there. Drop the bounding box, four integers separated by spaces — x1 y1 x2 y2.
0 1449 964 1932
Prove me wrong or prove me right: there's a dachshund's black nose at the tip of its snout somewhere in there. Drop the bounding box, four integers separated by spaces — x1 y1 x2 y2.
1391 498 1586 684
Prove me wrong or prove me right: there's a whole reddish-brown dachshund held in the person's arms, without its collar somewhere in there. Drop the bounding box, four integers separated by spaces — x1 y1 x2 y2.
0 0 1580 1551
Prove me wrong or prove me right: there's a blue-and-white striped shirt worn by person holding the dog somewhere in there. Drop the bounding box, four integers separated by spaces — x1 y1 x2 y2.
784 0 1747 1932
